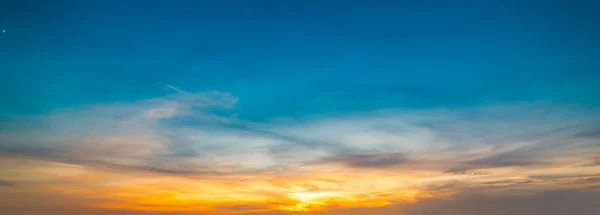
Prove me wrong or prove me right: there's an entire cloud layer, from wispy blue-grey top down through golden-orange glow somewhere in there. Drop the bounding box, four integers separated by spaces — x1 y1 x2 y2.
0 88 600 212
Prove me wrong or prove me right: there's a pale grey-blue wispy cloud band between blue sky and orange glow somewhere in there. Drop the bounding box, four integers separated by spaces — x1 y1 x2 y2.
0 97 594 181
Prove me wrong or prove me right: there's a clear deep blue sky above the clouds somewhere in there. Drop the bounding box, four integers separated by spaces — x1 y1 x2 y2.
0 0 600 121
